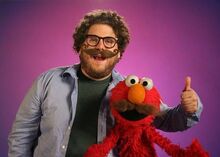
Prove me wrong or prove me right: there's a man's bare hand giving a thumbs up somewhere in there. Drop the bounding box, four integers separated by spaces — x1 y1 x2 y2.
181 76 198 114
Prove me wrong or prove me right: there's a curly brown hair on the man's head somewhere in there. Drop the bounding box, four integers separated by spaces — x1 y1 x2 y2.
73 10 130 55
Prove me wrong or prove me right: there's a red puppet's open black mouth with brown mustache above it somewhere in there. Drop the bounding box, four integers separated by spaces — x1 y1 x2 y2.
112 100 159 121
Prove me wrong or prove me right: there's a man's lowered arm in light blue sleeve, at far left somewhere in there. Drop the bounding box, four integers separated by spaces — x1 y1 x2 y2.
8 77 42 157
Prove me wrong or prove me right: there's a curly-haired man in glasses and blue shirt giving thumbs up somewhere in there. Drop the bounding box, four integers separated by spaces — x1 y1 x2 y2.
9 10 202 157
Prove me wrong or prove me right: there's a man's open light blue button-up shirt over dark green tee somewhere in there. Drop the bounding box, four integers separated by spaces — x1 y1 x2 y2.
8 65 202 157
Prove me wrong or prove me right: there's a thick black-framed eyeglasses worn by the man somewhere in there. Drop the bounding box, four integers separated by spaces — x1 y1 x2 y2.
86 34 118 49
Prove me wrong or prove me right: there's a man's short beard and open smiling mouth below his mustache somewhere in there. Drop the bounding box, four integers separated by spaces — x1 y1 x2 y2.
79 48 119 79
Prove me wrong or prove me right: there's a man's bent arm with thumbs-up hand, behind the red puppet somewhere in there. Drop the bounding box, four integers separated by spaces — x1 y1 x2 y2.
154 77 203 131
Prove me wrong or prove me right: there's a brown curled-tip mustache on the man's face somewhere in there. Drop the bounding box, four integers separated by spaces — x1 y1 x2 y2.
82 48 119 58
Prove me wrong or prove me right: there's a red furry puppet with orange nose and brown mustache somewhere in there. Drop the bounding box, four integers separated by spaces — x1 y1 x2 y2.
84 75 209 157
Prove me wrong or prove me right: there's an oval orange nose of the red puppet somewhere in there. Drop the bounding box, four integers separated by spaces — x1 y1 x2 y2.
128 84 145 105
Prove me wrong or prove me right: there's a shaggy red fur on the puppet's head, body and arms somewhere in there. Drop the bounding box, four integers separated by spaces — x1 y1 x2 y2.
84 79 209 157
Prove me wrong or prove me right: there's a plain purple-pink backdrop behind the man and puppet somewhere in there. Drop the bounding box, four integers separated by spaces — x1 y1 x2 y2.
0 0 220 157
